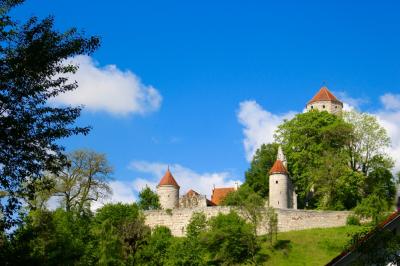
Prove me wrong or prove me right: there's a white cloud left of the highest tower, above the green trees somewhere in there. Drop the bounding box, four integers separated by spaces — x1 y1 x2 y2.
237 101 295 161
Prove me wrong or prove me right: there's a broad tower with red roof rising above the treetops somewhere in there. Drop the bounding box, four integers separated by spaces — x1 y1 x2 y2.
306 86 343 114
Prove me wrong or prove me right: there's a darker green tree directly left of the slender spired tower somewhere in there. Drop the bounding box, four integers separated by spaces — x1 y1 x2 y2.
245 143 279 198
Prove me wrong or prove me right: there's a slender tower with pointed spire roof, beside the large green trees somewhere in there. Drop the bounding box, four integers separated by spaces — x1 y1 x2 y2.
269 146 297 209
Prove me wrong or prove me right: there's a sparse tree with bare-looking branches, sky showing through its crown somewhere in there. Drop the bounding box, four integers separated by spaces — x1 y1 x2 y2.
50 150 112 213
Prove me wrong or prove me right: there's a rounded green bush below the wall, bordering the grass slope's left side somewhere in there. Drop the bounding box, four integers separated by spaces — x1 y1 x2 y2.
201 212 259 265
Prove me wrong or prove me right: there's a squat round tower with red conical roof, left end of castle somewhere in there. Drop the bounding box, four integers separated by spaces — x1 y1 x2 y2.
157 167 179 210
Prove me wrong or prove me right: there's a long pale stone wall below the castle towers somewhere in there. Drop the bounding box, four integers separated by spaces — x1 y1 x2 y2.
145 206 351 236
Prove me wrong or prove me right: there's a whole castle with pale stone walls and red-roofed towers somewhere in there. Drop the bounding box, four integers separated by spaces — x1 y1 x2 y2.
145 86 350 236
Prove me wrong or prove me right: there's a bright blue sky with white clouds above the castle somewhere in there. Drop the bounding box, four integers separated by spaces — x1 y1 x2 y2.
13 0 400 204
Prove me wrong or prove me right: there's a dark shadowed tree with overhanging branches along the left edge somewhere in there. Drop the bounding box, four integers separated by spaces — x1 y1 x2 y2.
0 0 99 227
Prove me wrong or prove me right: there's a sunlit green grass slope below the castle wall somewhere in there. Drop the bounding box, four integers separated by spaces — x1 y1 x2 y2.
263 226 359 266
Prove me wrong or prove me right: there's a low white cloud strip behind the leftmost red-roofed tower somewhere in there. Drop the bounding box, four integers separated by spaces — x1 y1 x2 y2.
130 161 241 198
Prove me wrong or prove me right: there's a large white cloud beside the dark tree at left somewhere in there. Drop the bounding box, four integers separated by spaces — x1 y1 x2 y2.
52 55 162 115
